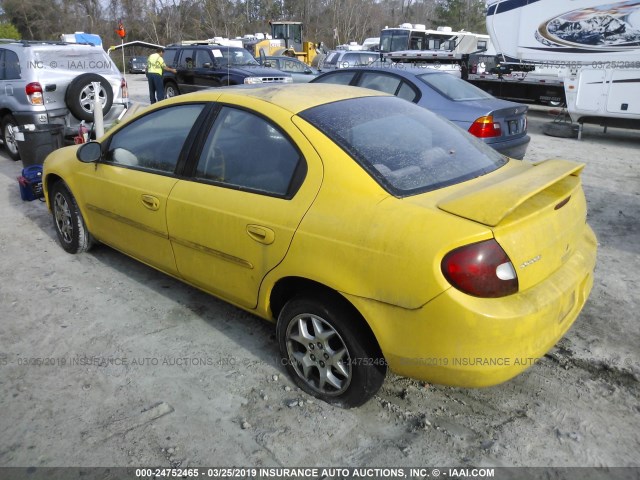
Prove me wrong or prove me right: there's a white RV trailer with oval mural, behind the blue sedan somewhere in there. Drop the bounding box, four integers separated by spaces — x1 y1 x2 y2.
487 0 640 128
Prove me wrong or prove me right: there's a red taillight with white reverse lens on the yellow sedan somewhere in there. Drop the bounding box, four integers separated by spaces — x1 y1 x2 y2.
442 239 518 298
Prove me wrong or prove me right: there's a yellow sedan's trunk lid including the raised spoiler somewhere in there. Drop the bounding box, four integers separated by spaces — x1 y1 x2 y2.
438 160 587 290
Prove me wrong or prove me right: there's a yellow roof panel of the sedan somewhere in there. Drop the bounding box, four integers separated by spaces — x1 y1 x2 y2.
165 83 390 113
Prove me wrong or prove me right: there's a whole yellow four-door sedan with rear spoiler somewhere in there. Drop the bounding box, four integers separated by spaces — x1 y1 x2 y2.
44 84 596 407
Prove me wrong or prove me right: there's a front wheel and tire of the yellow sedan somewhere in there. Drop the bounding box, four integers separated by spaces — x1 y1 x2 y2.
50 181 93 253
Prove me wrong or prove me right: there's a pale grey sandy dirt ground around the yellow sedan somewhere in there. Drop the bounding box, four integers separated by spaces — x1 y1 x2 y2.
0 76 640 467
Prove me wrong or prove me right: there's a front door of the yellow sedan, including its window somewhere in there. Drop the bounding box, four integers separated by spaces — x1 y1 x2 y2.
81 103 205 274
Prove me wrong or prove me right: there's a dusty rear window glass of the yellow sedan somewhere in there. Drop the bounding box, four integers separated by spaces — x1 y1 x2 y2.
300 96 507 197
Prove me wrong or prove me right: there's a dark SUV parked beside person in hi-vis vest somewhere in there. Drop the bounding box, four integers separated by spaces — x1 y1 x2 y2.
163 44 292 97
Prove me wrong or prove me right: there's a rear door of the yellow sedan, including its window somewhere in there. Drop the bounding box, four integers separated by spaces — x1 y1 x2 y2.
167 106 322 308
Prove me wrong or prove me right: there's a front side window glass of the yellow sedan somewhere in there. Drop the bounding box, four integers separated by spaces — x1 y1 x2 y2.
106 104 204 174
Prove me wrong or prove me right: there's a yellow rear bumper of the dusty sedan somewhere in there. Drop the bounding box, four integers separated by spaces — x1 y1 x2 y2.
347 225 597 387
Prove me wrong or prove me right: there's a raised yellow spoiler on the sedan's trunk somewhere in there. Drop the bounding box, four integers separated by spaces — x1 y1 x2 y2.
438 159 585 227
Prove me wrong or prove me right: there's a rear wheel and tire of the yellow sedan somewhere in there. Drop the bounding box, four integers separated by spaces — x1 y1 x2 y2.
276 294 387 408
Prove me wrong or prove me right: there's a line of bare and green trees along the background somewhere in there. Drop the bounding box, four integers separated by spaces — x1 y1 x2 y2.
0 0 486 48
